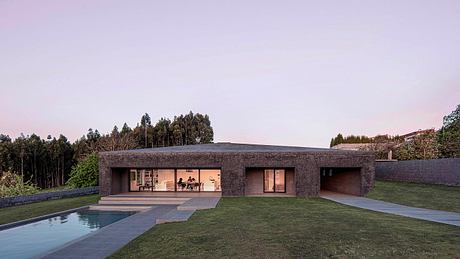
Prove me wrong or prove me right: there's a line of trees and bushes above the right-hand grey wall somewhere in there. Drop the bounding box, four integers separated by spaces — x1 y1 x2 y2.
330 105 460 160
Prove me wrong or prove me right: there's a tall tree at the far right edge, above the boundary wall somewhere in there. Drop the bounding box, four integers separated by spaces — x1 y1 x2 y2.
437 104 460 157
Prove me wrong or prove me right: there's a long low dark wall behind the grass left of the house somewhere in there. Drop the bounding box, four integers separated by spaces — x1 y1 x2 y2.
0 187 99 208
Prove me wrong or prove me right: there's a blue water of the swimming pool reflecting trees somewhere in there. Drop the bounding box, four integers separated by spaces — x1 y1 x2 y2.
0 210 133 258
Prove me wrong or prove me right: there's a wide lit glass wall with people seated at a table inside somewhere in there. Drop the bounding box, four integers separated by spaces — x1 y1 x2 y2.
129 169 221 192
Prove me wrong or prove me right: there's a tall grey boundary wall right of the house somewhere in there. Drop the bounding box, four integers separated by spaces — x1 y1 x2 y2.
375 158 460 186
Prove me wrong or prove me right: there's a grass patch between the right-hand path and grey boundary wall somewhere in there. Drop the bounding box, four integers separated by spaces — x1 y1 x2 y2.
367 181 460 212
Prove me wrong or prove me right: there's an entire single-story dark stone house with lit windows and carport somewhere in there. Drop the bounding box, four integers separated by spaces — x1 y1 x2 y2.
99 142 374 197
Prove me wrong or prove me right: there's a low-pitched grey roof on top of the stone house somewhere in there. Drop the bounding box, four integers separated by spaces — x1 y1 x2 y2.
101 142 368 154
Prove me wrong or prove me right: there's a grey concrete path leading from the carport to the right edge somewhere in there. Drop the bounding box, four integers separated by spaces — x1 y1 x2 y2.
320 192 460 227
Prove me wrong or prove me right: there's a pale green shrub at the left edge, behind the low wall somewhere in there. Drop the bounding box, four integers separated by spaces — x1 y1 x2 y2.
0 172 39 198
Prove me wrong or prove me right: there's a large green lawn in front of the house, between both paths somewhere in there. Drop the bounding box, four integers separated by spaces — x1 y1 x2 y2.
111 197 460 258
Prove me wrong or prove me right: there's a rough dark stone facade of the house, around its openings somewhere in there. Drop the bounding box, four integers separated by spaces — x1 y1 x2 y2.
99 144 374 197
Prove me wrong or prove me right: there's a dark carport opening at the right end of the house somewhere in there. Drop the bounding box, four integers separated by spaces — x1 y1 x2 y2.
320 167 361 195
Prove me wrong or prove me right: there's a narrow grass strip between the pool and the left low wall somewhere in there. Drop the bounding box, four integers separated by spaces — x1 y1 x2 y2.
0 195 99 224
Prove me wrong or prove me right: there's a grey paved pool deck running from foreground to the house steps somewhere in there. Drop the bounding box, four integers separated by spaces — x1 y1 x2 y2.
42 197 220 259
